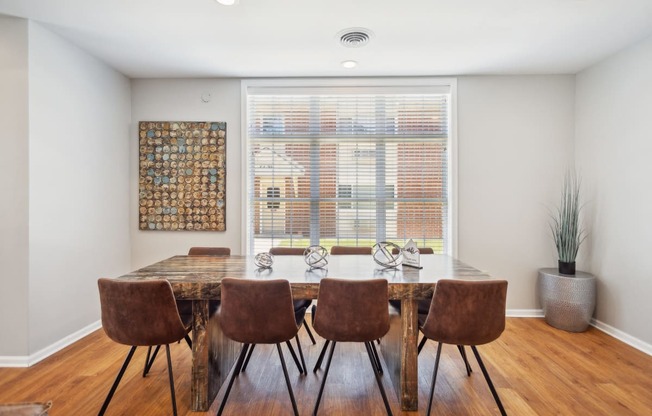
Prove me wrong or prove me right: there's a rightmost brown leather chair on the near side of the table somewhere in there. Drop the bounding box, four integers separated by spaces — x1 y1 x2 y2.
421 279 507 416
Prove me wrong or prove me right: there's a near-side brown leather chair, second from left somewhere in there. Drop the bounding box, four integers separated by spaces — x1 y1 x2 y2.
217 278 303 416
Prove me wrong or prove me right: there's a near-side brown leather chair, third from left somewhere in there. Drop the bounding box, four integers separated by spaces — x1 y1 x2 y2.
313 279 392 415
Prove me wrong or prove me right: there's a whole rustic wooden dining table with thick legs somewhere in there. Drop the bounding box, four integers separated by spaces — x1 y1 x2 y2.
119 254 491 411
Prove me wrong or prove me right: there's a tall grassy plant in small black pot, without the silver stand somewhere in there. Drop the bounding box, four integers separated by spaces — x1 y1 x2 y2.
550 171 586 275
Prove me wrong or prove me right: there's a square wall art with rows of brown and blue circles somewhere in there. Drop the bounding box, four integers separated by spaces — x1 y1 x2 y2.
138 121 226 231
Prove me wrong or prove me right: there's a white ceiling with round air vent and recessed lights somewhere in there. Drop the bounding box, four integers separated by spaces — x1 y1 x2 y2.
0 0 652 78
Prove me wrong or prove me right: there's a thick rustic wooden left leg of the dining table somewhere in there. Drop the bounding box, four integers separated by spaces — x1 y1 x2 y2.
190 300 240 412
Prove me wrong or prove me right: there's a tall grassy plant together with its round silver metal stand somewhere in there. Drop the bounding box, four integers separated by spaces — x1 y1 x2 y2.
539 171 596 332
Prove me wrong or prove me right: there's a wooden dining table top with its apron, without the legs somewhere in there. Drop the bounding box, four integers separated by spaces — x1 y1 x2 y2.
120 254 491 299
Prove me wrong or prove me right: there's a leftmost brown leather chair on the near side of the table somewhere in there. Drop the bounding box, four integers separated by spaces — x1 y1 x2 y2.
97 278 188 416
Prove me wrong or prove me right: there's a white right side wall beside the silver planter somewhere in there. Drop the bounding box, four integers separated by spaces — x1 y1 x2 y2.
576 33 652 345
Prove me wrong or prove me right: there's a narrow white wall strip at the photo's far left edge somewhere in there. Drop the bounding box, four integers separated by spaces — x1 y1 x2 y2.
0 15 29 357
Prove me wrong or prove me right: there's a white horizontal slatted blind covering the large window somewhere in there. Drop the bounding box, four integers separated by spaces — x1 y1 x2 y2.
246 87 450 253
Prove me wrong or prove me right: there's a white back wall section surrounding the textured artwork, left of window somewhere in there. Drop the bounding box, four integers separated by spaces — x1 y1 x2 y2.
129 79 244 269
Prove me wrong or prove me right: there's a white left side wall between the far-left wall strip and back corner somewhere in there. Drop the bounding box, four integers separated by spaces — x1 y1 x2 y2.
29 22 131 354
